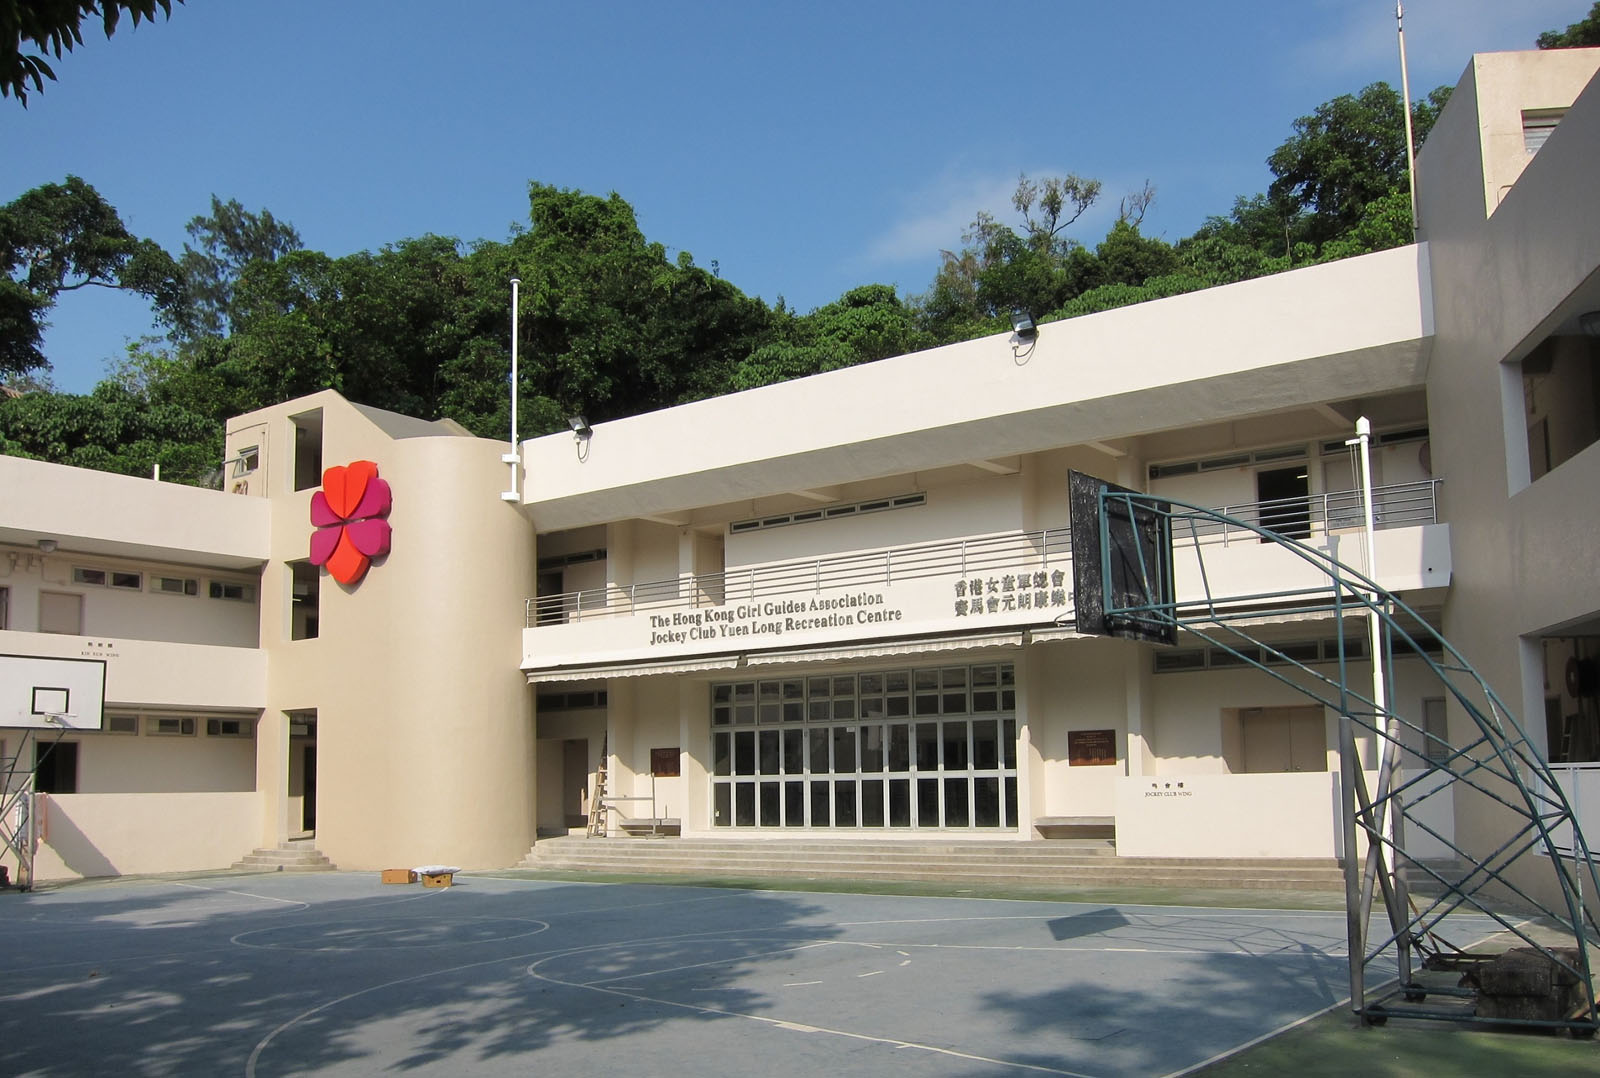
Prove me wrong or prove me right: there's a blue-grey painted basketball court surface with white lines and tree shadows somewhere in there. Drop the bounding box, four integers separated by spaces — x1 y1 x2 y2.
0 873 1490 1078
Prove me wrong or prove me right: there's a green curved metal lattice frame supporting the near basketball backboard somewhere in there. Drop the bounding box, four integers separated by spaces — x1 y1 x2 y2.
1078 483 1600 1036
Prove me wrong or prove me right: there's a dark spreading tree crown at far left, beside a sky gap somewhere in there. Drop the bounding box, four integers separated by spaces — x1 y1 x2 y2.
0 176 184 376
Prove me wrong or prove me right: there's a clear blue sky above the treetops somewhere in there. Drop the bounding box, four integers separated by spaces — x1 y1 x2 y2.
0 0 1589 392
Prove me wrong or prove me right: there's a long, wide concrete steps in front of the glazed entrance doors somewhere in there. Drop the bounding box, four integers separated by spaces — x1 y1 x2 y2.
518 836 1344 892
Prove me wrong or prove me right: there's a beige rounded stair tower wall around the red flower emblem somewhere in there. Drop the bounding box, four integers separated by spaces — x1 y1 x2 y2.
234 393 536 868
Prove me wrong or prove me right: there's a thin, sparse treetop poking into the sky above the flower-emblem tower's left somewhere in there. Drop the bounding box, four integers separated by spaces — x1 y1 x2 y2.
178 195 301 336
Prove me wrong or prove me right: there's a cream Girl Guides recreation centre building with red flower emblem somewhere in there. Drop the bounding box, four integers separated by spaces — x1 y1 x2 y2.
0 50 1600 908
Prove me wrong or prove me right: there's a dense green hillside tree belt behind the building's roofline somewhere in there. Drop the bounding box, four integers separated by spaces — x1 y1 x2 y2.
0 67 1465 481
